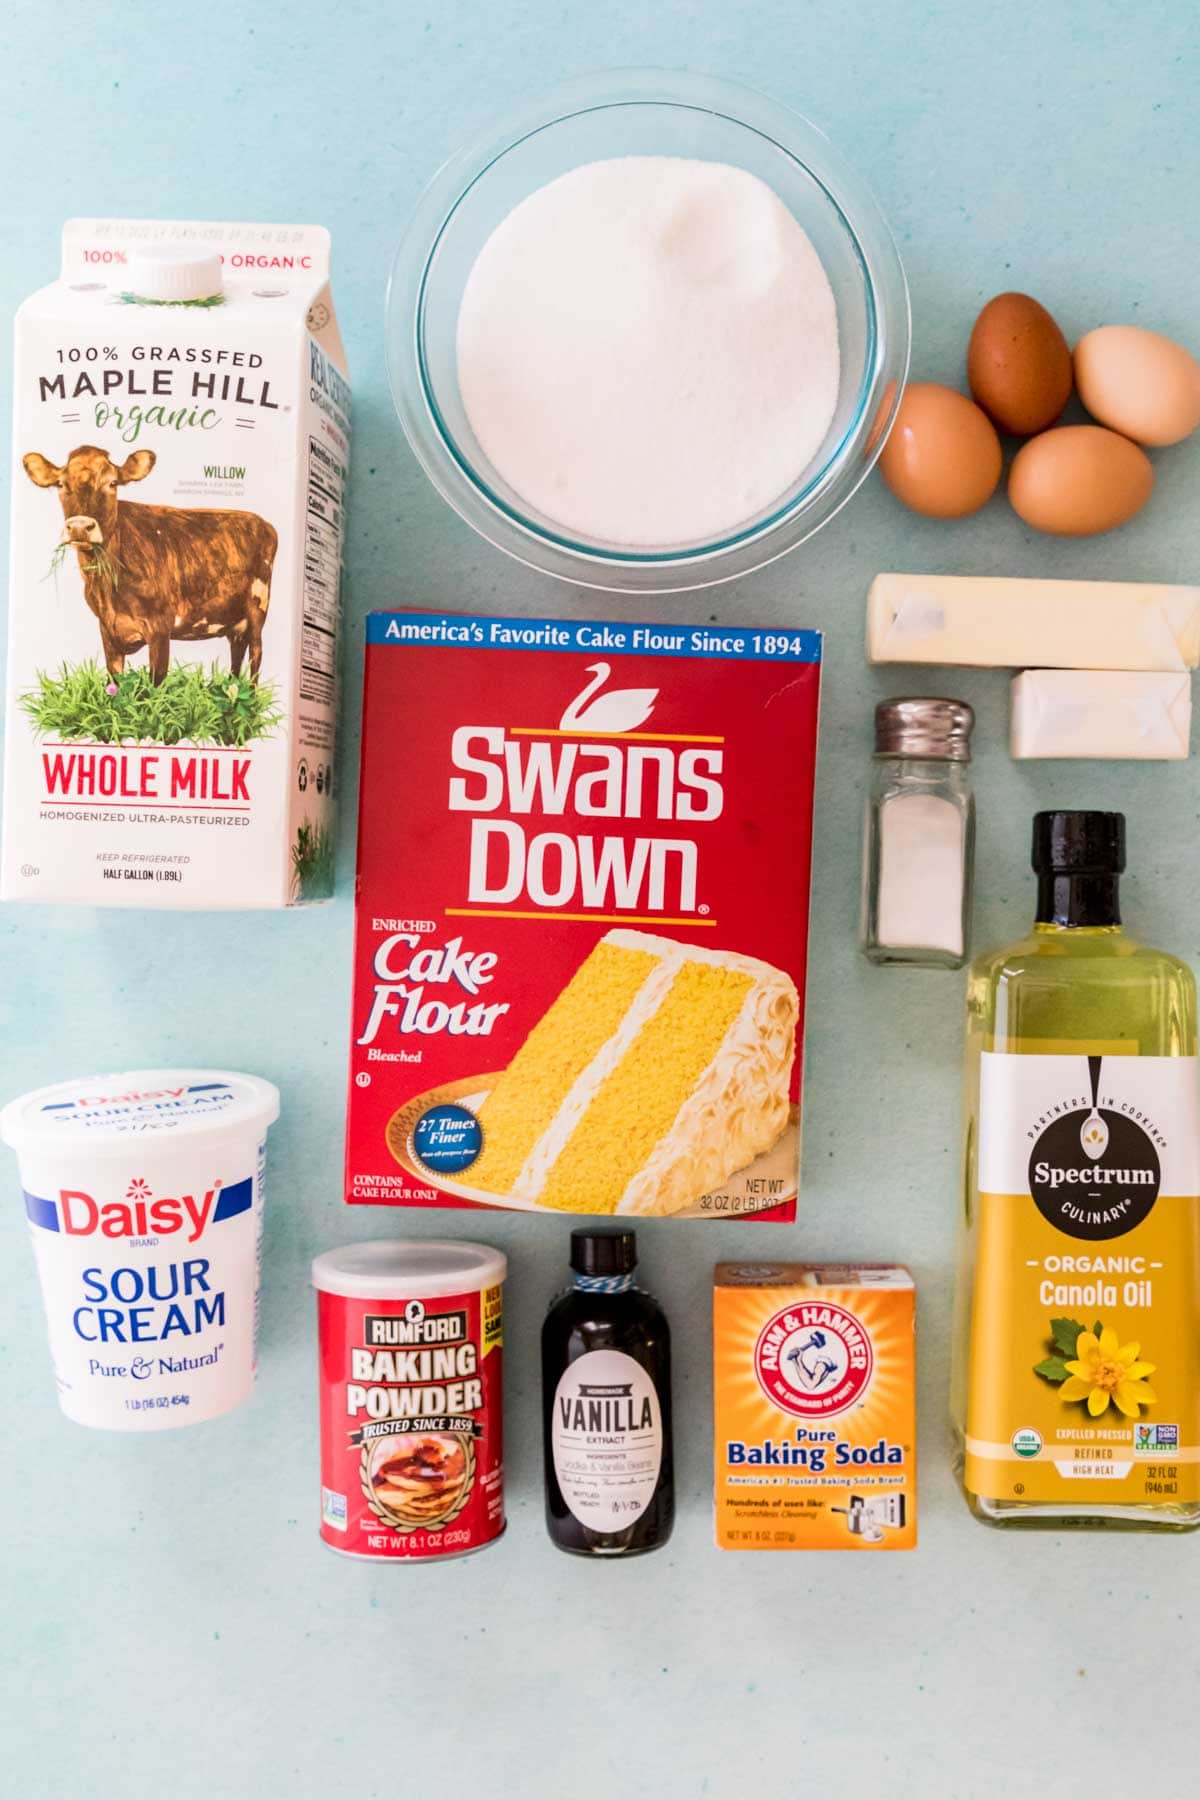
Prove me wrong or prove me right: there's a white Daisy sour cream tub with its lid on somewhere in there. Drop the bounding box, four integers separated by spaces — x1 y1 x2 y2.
0 1069 279 1431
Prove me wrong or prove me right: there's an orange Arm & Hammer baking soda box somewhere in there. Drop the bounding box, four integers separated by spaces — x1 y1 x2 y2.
712 1262 918 1550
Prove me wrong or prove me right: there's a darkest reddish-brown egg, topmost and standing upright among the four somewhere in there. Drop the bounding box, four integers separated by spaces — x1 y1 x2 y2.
966 293 1070 437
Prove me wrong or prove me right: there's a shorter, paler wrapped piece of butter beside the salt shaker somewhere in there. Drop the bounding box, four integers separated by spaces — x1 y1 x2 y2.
1009 670 1191 761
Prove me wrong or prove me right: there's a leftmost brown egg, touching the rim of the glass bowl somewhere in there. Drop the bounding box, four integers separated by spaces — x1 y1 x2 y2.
880 382 1000 518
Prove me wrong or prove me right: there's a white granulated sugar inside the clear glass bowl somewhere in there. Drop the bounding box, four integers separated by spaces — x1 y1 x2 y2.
457 157 838 549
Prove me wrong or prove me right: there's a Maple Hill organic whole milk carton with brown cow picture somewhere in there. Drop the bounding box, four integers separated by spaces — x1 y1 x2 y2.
0 220 349 907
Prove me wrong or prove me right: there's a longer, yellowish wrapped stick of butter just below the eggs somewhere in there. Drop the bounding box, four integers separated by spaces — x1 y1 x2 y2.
867 574 1200 670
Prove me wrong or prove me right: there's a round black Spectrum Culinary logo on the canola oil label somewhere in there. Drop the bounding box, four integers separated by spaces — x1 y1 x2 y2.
1029 1057 1162 1240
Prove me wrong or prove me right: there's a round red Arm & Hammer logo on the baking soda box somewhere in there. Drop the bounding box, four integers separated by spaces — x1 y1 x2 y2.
754 1300 874 1418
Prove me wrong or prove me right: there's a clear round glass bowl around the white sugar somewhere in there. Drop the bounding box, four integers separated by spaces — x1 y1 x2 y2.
387 70 910 594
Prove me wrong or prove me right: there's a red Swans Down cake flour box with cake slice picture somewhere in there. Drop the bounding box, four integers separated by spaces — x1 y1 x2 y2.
345 612 820 1219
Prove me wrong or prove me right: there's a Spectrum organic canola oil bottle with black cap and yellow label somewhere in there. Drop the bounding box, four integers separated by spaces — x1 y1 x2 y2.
954 812 1200 1530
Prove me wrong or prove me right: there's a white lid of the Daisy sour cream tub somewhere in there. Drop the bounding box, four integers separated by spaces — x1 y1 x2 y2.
0 1069 279 1156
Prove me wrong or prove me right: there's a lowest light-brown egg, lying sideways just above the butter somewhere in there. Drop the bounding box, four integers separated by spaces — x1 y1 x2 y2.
1007 425 1155 538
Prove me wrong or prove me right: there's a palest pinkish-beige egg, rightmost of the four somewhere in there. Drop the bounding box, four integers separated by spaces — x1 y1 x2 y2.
1076 326 1200 445
